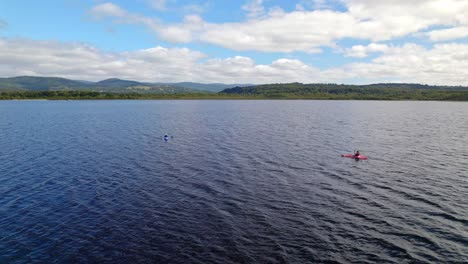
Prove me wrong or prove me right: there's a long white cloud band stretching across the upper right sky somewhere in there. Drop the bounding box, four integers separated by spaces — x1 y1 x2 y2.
91 0 468 52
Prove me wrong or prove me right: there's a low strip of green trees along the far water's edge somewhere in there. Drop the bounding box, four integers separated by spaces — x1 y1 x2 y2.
0 89 468 101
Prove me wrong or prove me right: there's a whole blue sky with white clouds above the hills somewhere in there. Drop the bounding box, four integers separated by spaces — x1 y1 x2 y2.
0 0 468 86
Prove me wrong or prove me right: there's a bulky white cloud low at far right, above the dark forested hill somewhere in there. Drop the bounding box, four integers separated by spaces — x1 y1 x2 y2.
327 44 468 85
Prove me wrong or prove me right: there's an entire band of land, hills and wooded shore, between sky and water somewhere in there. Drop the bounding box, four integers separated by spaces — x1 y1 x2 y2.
0 80 468 101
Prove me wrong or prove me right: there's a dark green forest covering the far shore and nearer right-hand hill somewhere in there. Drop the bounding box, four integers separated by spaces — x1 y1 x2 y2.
0 79 468 101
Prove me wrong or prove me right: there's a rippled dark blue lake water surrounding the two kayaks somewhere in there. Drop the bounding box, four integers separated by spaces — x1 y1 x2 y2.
0 101 468 263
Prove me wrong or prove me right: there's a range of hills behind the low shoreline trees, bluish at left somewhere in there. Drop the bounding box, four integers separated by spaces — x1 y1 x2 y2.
0 76 468 100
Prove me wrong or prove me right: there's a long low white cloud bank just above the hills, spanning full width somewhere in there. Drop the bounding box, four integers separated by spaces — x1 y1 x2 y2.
0 38 468 85
